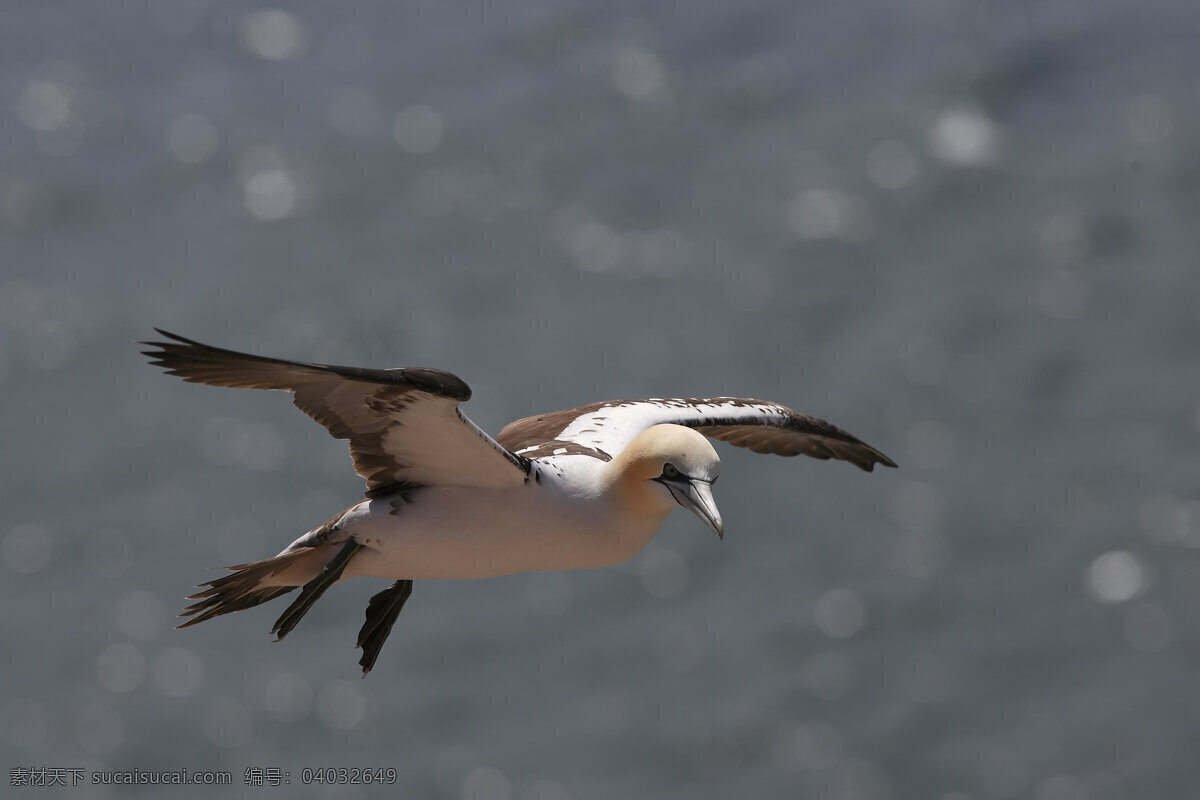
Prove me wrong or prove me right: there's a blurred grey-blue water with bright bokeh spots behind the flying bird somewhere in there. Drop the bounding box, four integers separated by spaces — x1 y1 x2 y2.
0 0 1200 800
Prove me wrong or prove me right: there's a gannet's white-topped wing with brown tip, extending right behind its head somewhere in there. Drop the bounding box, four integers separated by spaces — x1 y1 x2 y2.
496 397 895 473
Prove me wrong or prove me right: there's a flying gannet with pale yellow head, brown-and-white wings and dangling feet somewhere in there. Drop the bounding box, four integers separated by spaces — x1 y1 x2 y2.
143 329 895 675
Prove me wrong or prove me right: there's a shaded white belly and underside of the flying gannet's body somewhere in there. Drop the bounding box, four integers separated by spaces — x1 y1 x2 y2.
344 486 665 581
